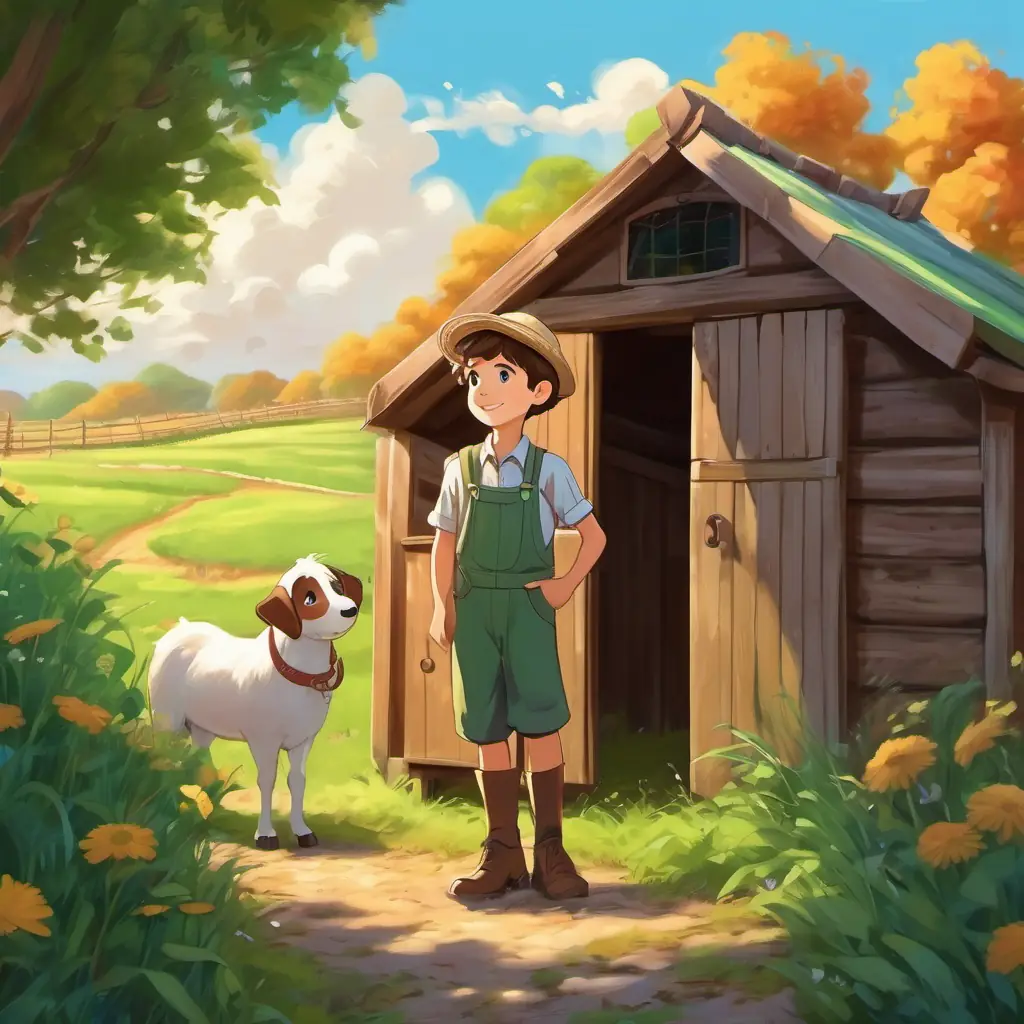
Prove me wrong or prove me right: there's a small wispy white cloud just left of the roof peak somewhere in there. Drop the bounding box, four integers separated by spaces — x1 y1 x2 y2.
415 57 669 145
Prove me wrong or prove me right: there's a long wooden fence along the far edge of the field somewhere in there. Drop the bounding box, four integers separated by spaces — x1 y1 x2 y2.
0 398 367 456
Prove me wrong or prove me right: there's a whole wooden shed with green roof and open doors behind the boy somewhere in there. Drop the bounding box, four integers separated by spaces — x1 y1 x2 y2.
367 87 1024 795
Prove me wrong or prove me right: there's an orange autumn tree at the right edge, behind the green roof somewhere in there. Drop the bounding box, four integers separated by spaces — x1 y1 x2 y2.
886 42 1024 271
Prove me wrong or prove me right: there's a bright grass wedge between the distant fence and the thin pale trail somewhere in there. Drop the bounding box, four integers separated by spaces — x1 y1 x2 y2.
90 419 376 495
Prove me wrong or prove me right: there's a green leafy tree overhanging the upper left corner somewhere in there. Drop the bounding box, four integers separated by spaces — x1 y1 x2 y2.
0 0 390 360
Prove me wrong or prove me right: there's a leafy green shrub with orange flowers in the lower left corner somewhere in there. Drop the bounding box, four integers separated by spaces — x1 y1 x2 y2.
0 488 302 1024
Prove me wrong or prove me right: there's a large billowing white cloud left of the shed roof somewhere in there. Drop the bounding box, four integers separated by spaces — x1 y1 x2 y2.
0 74 473 392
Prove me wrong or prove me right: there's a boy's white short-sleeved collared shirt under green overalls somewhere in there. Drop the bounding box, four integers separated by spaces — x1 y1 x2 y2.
427 434 594 544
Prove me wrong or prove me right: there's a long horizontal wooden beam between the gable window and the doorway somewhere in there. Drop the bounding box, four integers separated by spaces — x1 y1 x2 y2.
523 269 854 331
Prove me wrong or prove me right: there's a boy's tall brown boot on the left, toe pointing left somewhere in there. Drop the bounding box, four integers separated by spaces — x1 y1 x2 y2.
449 768 529 900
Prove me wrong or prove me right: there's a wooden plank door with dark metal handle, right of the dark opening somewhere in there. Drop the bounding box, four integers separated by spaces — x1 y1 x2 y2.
690 310 846 796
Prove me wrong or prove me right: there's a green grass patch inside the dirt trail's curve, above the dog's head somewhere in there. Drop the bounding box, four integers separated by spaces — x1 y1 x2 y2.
150 489 374 581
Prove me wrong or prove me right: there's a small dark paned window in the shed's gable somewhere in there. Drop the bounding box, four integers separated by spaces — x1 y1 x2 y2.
626 201 742 281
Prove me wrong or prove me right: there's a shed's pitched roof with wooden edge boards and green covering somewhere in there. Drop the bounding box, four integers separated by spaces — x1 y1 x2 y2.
367 86 1024 428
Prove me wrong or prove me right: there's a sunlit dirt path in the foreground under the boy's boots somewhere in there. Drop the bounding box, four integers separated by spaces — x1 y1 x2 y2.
209 844 798 1024
